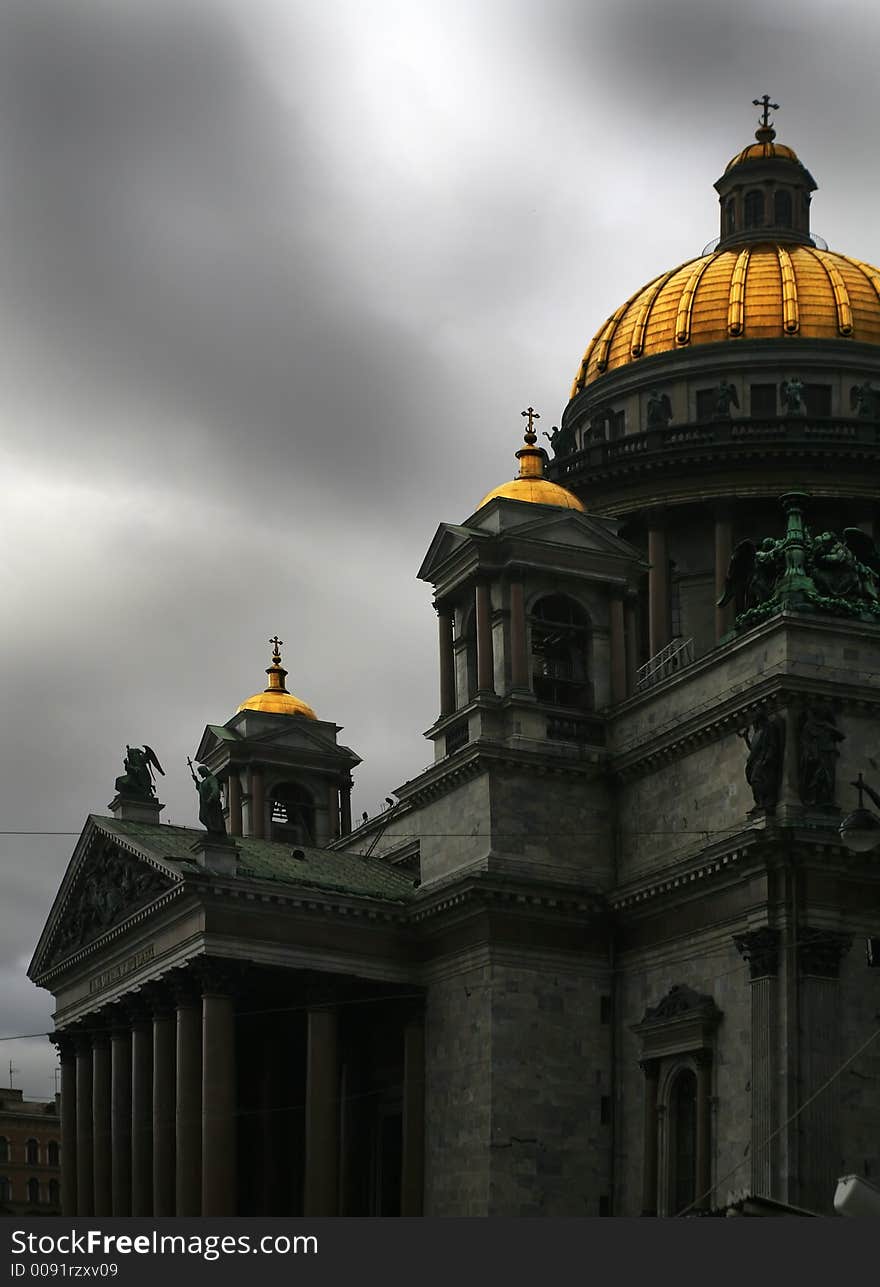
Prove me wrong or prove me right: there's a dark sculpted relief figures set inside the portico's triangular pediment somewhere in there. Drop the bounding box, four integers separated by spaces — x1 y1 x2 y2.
46 846 174 965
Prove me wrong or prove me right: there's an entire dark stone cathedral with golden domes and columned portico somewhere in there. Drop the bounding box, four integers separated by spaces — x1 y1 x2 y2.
28 97 880 1216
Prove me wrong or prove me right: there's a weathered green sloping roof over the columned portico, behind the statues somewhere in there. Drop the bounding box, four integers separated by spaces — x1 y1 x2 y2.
97 813 414 902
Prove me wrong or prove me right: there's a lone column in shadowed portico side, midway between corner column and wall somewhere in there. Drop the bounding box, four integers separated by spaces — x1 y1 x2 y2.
302 1009 340 1216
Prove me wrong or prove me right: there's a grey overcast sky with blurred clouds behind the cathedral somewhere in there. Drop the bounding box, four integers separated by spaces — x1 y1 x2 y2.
0 0 880 1095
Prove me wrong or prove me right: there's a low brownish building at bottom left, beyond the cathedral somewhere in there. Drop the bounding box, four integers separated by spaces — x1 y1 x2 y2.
0 1086 62 1215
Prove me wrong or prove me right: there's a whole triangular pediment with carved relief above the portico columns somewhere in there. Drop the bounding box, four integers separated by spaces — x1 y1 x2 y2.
28 819 180 978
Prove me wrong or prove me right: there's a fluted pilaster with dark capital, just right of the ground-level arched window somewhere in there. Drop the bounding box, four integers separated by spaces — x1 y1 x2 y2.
733 925 780 1198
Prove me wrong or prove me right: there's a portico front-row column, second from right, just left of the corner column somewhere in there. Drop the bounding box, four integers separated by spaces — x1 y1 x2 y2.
175 977 202 1216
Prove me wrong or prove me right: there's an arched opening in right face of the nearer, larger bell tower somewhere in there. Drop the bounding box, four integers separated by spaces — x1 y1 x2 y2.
529 595 592 710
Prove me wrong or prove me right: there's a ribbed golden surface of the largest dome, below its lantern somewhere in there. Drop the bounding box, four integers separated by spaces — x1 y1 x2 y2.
571 242 880 398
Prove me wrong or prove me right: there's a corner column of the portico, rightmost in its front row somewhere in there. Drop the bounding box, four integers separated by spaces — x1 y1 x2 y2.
202 964 238 1216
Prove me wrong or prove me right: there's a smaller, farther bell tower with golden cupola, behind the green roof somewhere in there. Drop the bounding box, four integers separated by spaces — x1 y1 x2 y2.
196 634 360 847
